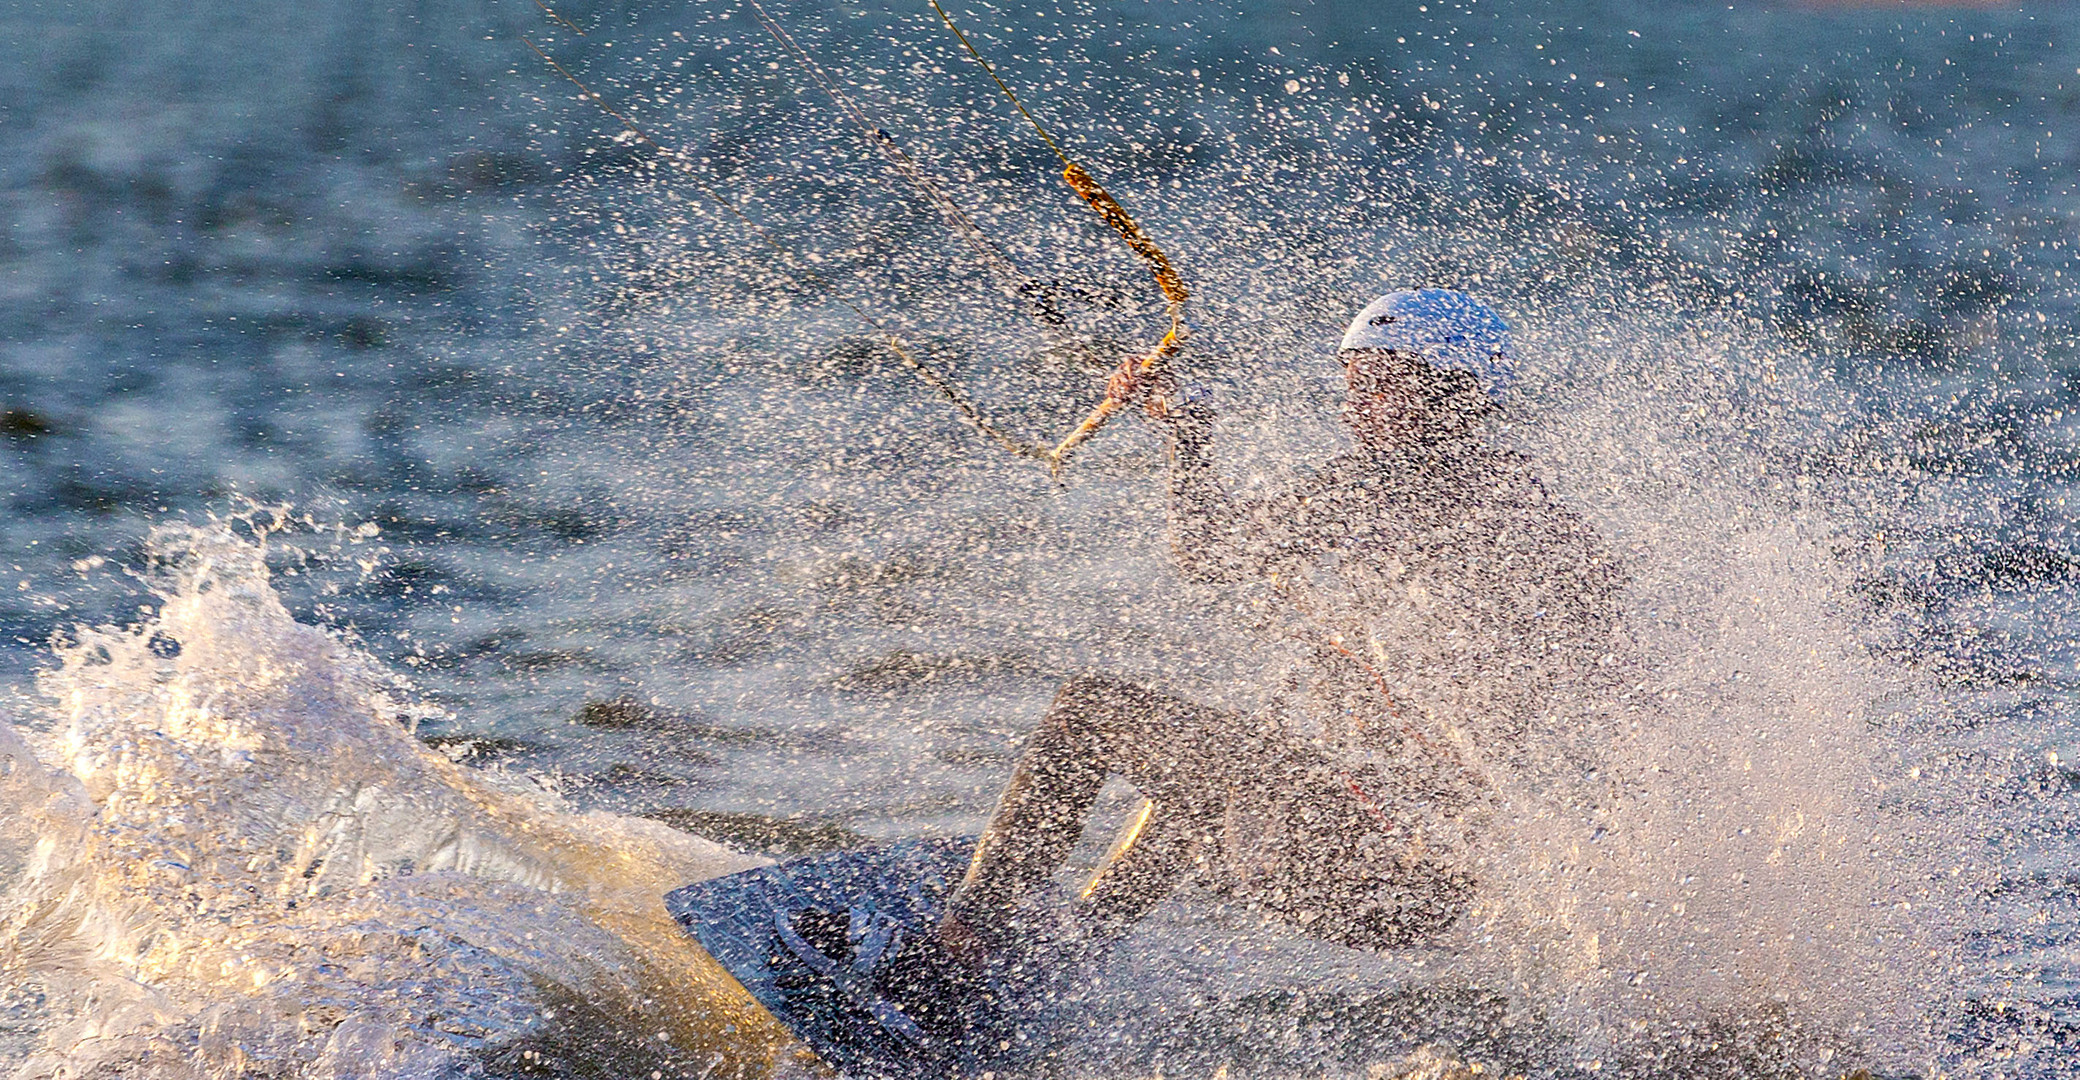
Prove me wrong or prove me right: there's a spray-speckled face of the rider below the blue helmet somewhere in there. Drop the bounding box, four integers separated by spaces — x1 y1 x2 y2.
1344 350 1493 449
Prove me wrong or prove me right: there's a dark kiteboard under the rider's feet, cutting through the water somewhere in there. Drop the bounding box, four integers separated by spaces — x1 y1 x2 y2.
666 839 1094 1080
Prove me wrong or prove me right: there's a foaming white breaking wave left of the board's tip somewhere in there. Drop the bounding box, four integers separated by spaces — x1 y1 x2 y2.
0 524 815 1078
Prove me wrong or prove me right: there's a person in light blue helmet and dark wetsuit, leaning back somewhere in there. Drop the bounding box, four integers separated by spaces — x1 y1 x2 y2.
940 289 1618 963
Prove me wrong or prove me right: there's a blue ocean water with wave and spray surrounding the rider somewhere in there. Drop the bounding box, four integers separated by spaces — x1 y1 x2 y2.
0 0 2080 1078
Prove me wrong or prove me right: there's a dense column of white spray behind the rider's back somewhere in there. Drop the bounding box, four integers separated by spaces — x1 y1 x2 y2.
1464 316 1963 1070
